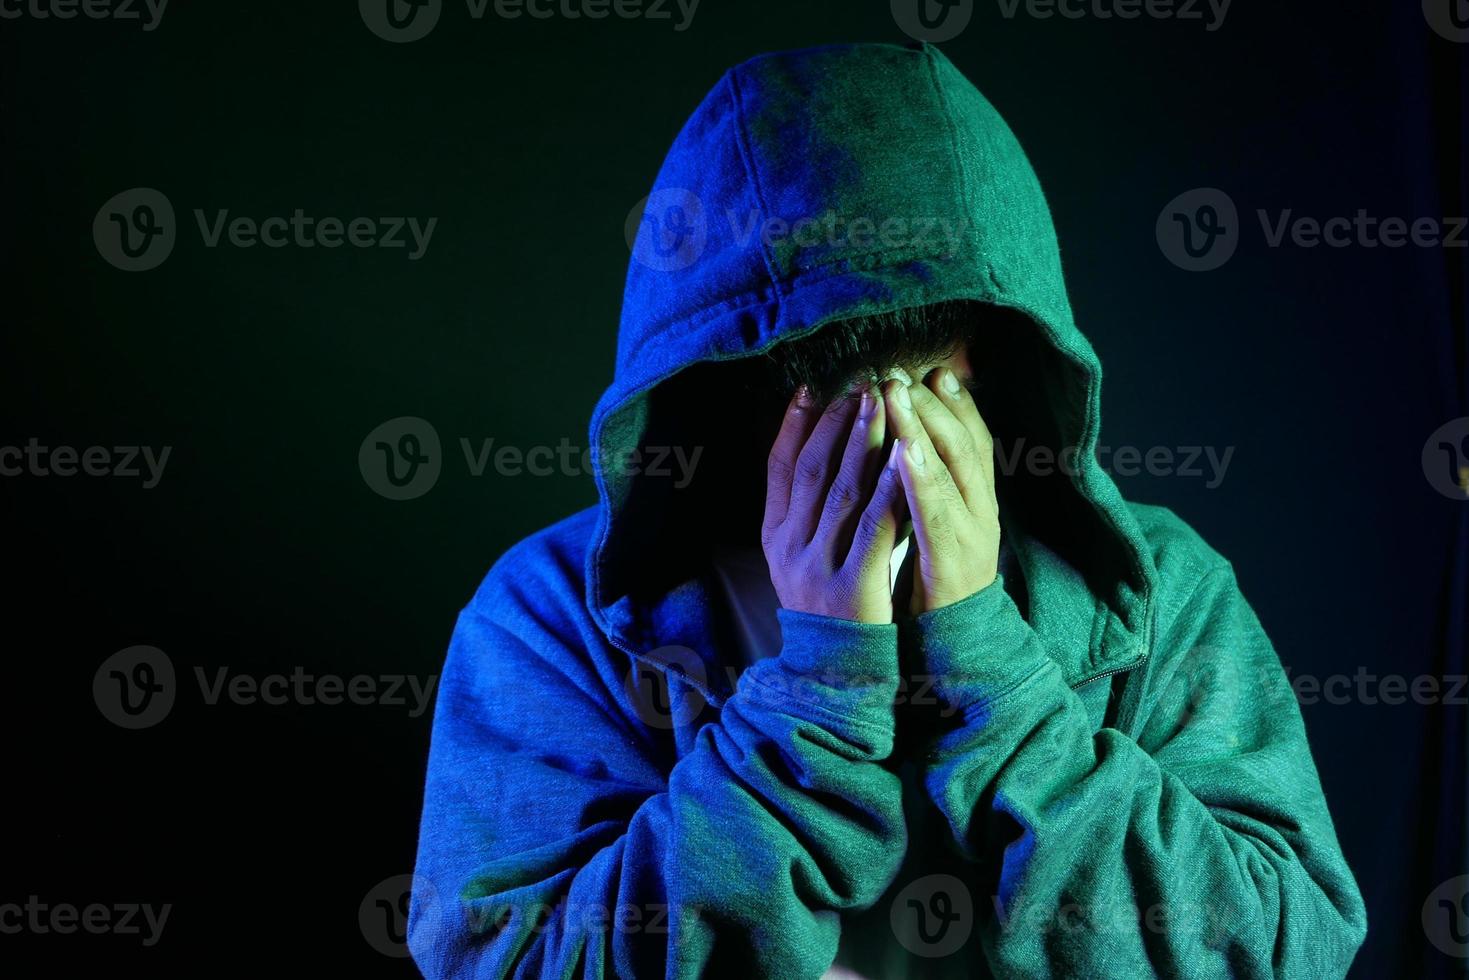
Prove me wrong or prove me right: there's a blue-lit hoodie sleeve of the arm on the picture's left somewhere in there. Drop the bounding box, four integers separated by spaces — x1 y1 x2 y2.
408 581 906 979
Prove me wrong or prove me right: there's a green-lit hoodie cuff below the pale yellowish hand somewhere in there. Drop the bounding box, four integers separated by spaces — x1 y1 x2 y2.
903 574 1050 708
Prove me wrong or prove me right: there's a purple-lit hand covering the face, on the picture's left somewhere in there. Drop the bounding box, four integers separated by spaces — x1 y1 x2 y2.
761 391 906 623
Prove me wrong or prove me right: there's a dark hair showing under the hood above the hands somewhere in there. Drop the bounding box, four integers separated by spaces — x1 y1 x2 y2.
765 303 972 406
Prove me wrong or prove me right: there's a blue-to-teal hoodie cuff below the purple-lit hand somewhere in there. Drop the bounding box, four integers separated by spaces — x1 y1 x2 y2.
743 608 898 732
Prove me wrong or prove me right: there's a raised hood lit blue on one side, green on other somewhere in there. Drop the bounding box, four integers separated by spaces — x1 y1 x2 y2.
586 44 1155 693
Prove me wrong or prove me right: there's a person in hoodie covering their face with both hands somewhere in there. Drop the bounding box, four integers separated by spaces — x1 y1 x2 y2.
410 46 1365 979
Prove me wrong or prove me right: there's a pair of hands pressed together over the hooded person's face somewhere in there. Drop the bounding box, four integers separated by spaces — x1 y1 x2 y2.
761 348 999 623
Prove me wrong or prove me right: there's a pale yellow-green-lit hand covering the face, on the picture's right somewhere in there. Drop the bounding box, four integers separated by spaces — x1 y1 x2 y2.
883 367 1000 616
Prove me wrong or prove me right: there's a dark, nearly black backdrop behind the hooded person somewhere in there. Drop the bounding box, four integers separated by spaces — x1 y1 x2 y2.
0 0 1469 977
